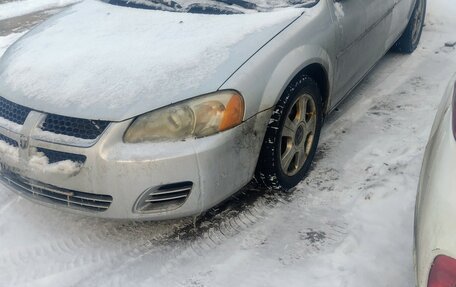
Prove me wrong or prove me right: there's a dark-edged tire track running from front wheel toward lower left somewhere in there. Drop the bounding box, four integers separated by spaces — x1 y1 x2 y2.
66 189 284 286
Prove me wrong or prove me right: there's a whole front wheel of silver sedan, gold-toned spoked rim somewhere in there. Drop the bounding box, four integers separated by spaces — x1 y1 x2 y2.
255 76 323 190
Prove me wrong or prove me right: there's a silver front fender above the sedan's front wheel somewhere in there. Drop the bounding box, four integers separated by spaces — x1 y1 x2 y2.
220 1 337 119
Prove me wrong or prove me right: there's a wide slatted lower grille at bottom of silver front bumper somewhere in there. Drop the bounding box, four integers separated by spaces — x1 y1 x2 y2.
0 170 112 212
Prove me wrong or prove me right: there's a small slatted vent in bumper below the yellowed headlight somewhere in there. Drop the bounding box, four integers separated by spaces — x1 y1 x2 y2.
135 181 193 213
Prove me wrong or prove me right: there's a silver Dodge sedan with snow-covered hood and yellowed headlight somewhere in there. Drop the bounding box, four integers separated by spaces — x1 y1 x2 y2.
0 0 426 219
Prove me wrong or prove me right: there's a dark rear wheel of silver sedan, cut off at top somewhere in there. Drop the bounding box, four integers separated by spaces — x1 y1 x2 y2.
393 0 426 54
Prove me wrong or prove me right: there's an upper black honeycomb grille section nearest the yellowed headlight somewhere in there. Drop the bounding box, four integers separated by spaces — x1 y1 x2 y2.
41 114 109 140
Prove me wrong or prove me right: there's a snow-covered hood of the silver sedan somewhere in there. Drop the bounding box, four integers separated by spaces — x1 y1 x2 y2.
0 0 302 121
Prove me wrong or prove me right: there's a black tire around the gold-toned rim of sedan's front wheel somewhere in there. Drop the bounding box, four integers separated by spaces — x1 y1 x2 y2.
255 76 323 191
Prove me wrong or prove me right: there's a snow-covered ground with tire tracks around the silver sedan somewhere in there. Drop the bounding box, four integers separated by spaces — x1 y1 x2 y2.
0 0 456 287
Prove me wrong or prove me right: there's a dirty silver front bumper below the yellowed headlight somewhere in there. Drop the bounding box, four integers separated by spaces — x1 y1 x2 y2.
0 110 271 220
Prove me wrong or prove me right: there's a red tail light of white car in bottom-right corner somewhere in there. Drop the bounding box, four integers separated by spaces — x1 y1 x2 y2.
428 255 456 287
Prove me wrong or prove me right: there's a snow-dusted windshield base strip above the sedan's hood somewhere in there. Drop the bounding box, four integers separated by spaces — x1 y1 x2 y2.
102 0 318 14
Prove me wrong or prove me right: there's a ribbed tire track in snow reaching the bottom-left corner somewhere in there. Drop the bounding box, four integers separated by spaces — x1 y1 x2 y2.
0 220 183 286
